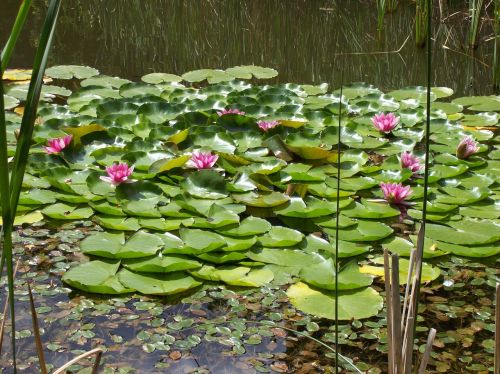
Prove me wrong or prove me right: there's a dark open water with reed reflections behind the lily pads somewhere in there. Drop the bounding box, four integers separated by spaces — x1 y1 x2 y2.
0 0 494 95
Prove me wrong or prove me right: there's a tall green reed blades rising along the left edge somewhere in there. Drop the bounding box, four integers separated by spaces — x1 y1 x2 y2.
0 0 61 372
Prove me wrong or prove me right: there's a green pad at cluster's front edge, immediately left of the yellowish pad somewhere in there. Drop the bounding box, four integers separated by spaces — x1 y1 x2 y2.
118 269 201 295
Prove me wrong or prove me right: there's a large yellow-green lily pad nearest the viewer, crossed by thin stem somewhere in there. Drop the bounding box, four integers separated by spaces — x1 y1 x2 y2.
287 282 383 321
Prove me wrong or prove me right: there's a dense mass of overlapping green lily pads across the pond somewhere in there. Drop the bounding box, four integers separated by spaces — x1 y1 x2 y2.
1 66 500 319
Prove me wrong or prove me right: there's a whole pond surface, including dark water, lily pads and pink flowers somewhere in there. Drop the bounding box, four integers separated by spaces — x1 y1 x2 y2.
0 0 500 374
